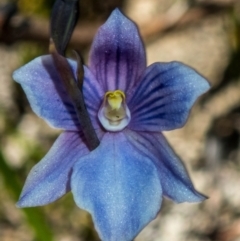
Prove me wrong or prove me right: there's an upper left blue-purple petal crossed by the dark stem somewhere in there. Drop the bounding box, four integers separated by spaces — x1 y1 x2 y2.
13 55 103 130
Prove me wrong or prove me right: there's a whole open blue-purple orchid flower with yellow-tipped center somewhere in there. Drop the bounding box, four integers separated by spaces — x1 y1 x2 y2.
13 9 209 241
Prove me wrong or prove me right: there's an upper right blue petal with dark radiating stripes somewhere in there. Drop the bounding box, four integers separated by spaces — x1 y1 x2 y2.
128 62 209 131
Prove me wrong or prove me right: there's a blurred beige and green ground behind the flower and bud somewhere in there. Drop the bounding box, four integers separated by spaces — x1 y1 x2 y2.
0 0 240 241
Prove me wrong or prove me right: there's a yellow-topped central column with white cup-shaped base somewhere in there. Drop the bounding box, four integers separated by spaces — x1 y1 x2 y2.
98 90 131 131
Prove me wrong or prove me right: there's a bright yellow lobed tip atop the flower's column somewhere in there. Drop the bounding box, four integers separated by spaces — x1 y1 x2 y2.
105 90 125 110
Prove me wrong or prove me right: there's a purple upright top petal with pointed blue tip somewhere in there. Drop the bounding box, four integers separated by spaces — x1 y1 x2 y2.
90 9 146 93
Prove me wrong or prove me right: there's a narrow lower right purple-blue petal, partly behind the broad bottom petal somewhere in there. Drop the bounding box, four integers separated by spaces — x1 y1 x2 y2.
126 130 205 203
